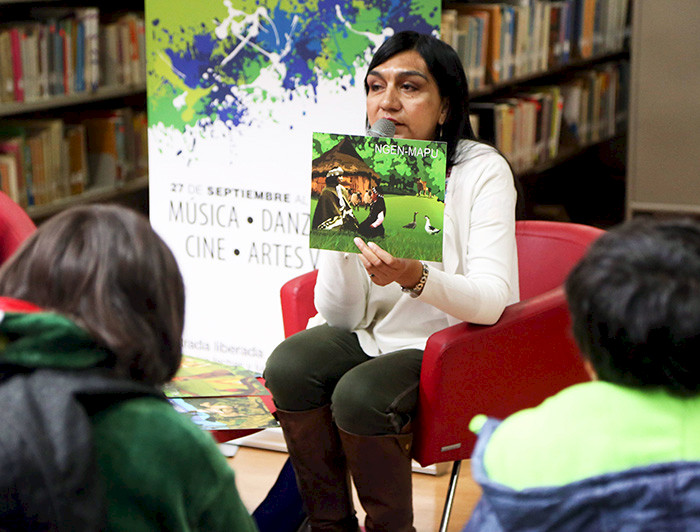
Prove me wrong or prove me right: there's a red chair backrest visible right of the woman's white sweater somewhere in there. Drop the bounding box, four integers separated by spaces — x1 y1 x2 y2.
515 220 603 301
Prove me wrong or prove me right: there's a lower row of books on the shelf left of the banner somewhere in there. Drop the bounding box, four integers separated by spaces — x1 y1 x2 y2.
0 107 148 207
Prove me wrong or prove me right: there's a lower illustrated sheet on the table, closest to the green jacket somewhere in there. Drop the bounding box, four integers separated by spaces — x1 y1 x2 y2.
170 396 279 430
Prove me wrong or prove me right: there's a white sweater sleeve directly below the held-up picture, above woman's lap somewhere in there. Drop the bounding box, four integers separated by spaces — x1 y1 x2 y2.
314 250 369 330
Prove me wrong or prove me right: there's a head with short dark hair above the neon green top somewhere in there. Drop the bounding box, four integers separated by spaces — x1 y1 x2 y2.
566 220 700 396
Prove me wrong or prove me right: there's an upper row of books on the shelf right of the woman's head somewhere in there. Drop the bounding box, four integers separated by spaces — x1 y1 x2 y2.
441 0 630 89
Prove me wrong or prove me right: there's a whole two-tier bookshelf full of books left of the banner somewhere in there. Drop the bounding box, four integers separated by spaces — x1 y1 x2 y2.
0 0 148 223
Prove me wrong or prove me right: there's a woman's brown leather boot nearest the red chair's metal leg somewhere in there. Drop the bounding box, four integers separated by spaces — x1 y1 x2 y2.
338 428 416 532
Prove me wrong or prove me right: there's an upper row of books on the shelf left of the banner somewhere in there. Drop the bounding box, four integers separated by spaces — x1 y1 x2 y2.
0 7 146 102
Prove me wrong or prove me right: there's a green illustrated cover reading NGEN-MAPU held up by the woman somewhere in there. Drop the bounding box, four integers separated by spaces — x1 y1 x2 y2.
309 133 447 262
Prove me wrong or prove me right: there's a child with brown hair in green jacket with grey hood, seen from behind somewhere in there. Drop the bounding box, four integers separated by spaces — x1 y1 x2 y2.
0 206 257 532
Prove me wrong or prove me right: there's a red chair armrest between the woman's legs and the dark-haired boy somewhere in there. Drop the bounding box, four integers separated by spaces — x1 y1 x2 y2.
413 288 588 466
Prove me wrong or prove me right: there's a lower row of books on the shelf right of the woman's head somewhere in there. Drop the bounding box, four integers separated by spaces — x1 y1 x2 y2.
470 61 629 173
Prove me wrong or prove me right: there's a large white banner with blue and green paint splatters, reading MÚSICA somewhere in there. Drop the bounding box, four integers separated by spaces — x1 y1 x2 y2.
146 0 440 371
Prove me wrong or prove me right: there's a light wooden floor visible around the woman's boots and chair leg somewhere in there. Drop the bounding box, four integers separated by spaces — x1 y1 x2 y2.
229 447 480 532
